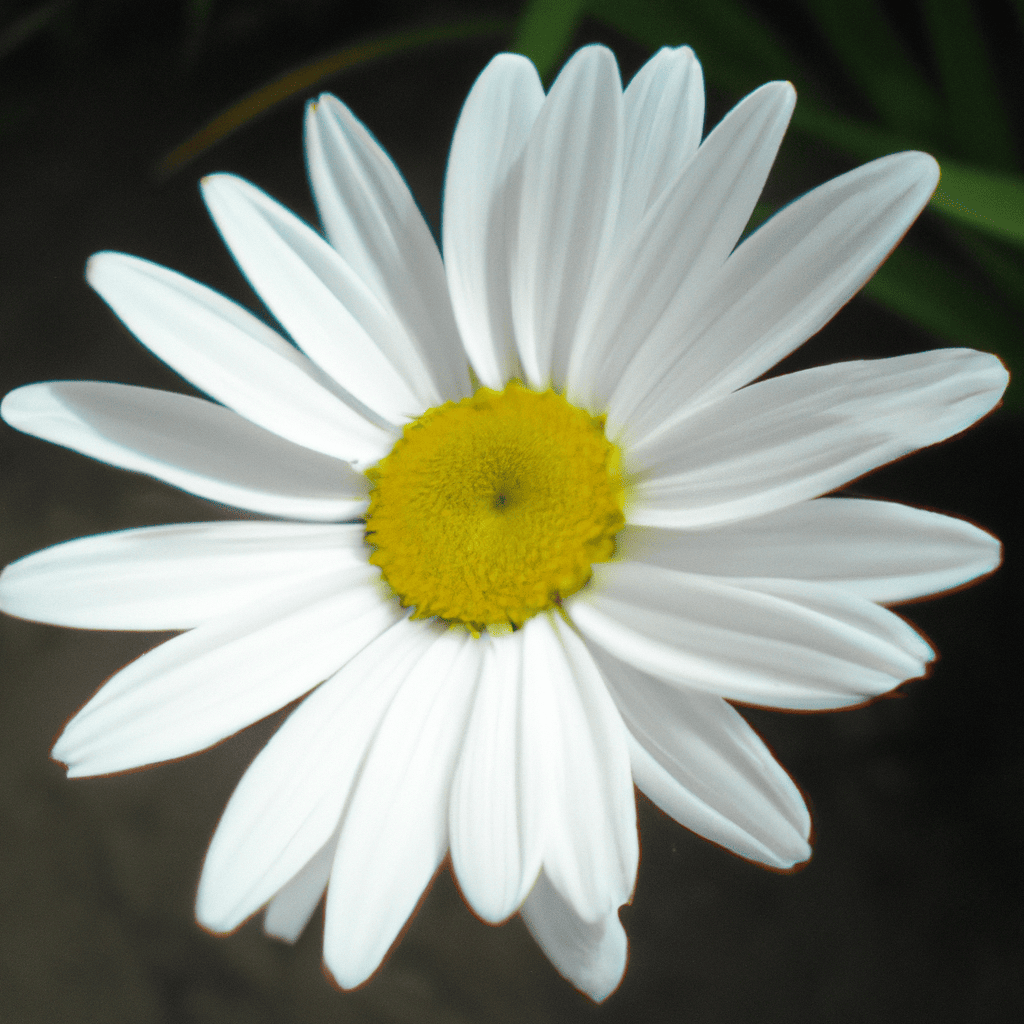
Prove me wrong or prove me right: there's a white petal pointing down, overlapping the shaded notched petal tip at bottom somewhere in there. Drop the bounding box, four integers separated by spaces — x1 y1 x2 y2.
521 613 639 922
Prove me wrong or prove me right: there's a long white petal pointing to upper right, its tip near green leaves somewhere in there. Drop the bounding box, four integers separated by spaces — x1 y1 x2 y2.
608 153 938 438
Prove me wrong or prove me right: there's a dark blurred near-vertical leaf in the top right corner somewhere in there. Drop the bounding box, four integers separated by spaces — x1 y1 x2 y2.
922 0 1017 171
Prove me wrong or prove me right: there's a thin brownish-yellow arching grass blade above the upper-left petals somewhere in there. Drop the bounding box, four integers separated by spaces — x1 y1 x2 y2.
157 18 511 177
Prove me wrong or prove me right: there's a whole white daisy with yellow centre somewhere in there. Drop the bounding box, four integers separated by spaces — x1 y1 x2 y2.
0 46 1007 999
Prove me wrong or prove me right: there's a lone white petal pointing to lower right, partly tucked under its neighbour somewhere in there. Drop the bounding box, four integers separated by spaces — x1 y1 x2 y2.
598 654 811 868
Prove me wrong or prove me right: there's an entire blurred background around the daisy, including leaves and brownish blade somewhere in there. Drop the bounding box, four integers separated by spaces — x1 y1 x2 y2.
0 0 1024 1024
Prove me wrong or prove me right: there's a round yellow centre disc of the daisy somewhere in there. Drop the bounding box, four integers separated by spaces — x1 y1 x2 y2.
367 382 625 634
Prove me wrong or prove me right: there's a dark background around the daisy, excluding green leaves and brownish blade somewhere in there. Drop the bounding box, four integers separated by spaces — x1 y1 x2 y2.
0 0 1024 1024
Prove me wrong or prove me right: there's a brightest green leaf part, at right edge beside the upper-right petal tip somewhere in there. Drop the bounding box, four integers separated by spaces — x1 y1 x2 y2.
932 160 1024 248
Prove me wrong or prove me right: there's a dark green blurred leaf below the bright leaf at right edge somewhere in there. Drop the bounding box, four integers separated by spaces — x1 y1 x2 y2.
864 246 1024 408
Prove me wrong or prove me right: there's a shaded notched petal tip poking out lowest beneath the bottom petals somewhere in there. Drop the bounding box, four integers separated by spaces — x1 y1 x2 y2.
522 873 627 1002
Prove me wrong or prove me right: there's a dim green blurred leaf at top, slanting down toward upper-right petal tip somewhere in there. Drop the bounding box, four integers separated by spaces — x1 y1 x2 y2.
804 0 942 145
